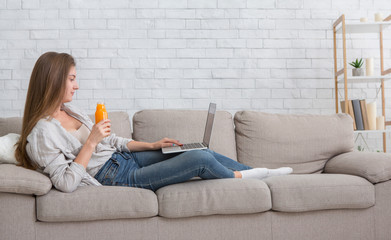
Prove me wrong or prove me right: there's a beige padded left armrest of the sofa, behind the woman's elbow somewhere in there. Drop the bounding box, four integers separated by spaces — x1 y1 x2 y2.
0 164 52 195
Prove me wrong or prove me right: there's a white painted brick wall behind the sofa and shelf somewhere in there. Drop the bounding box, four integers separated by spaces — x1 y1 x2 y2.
0 0 391 150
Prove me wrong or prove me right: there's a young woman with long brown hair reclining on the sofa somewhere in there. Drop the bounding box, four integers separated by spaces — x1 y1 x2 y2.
15 52 292 192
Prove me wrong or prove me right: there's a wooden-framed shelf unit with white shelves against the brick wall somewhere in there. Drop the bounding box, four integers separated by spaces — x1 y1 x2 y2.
333 14 391 152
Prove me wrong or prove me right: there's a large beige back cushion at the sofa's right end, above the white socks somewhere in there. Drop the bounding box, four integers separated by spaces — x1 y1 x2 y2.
235 111 354 173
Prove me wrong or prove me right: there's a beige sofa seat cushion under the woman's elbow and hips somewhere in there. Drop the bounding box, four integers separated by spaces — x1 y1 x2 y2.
37 186 158 222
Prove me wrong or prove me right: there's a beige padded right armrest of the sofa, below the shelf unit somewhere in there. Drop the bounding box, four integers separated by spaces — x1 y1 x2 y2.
324 152 391 183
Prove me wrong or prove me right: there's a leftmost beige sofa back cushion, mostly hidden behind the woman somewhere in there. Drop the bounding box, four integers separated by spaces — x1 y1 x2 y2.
0 112 132 138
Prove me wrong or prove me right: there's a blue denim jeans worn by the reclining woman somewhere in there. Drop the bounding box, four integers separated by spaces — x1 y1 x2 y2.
95 149 251 191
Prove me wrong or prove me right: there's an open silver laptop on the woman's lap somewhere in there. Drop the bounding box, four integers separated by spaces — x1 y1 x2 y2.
162 103 216 154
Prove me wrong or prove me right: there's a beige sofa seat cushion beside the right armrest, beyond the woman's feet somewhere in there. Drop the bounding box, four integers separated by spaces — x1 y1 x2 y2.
265 174 375 212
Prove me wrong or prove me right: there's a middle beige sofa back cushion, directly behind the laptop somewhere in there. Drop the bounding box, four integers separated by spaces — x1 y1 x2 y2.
133 110 236 160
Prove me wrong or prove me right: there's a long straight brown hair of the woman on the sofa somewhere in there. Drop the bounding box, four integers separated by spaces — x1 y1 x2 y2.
15 52 75 169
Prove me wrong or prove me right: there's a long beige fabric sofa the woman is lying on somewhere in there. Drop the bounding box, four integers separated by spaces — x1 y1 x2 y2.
0 110 391 240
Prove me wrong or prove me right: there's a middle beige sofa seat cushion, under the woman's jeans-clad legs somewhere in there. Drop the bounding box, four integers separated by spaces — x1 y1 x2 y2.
156 179 271 218
